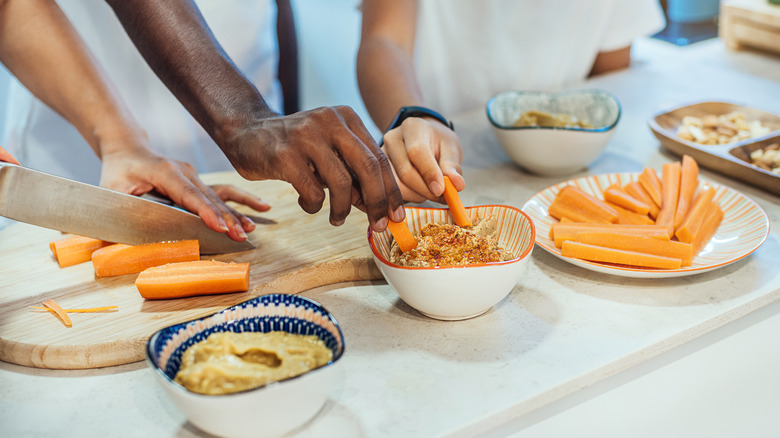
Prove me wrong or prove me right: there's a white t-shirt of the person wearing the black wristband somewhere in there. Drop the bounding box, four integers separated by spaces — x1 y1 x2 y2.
415 0 664 115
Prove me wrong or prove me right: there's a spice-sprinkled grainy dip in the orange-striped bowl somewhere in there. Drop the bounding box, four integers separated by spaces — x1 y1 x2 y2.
390 219 515 267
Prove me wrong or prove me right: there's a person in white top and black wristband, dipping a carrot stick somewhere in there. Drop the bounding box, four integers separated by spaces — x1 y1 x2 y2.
357 0 664 202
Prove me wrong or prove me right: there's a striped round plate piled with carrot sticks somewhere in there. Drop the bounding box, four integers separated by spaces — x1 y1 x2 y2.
522 155 769 278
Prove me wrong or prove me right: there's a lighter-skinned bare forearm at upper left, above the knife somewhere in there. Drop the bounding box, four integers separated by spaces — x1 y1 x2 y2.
0 0 140 156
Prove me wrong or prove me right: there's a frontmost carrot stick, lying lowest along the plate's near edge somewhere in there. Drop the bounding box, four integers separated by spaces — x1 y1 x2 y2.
561 240 682 269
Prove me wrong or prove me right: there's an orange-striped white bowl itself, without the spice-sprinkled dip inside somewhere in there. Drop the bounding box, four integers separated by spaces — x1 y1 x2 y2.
368 205 535 320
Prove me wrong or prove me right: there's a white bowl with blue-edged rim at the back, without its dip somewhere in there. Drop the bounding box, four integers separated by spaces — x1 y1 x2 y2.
487 90 620 176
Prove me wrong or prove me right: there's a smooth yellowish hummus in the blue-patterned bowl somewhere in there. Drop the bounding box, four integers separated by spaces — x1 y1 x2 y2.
174 332 333 395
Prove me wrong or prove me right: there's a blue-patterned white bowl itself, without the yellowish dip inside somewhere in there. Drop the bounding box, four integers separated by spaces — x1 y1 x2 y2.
146 294 344 437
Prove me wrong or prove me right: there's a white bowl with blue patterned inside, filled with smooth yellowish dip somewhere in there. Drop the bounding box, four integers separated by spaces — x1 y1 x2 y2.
146 294 344 437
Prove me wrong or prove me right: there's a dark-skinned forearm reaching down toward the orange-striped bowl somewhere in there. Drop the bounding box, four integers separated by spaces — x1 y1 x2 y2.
107 0 276 147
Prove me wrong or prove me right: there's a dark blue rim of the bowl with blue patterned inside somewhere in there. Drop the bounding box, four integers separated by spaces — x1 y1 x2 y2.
145 293 347 399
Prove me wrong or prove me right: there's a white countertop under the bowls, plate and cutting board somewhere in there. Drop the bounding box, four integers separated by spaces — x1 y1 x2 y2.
0 40 780 438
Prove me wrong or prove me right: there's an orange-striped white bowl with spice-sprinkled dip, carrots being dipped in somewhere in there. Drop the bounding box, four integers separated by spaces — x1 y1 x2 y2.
368 205 535 320
